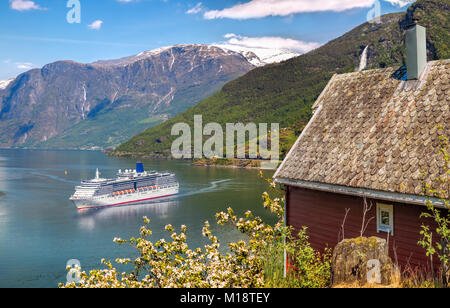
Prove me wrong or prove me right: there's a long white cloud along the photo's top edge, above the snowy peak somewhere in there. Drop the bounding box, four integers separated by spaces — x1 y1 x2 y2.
203 0 376 19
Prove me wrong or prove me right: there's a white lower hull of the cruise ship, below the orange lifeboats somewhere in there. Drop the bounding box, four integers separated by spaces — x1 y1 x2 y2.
71 186 179 210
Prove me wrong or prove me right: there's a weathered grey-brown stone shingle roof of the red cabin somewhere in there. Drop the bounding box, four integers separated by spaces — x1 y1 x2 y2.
275 60 450 195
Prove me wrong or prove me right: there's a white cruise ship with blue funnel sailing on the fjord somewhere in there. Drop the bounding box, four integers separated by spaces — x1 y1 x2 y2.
70 163 179 210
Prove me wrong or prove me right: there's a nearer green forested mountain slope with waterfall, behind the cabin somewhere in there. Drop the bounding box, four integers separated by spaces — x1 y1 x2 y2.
113 0 450 157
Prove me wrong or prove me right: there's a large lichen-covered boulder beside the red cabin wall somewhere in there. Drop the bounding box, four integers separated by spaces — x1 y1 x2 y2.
333 237 395 285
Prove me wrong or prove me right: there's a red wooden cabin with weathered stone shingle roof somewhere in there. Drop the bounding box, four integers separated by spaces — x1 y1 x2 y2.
274 25 450 268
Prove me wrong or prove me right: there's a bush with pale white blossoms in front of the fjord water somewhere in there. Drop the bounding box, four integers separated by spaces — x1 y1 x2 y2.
60 173 327 288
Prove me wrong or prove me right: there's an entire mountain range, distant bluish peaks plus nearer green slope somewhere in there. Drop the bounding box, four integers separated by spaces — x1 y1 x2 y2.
0 0 450 156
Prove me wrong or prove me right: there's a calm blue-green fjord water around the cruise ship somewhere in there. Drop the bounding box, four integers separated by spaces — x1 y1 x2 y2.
0 150 275 288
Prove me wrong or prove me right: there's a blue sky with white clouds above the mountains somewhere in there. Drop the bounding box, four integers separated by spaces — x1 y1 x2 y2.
0 0 413 80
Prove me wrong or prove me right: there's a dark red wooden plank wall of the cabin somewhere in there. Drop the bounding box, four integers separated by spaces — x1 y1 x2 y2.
286 187 439 271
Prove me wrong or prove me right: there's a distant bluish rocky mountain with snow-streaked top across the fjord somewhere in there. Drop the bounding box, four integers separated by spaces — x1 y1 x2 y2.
0 44 296 149
